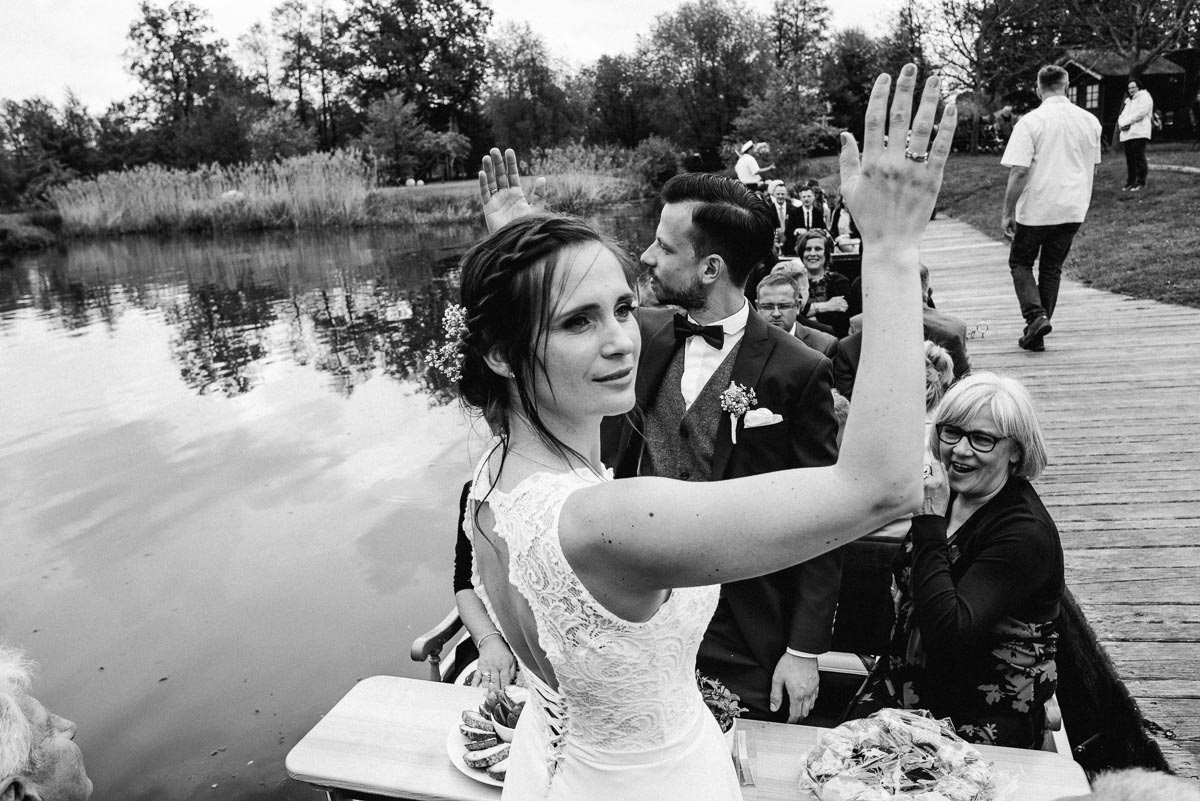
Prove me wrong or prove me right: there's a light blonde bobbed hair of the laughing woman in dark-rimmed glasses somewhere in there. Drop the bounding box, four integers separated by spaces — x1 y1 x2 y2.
929 373 1048 481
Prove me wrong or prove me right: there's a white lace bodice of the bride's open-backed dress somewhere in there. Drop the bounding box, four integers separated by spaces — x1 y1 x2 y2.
467 465 720 752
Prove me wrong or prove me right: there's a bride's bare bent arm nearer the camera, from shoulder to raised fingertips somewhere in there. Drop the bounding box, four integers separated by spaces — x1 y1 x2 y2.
559 65 955 600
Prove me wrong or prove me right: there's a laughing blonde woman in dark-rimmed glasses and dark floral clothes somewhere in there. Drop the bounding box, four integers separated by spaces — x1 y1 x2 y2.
856 373 1064 748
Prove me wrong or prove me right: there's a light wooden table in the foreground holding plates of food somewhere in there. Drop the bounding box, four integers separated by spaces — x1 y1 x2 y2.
287 676 1088 801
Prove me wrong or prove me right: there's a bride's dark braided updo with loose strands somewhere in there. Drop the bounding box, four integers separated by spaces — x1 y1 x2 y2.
458 216 632 450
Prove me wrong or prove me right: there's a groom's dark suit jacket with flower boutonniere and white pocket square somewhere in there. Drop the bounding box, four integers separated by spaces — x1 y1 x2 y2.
604 309 841 710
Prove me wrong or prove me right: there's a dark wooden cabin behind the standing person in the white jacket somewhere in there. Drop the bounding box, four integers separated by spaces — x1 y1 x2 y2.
1058 49 1200 143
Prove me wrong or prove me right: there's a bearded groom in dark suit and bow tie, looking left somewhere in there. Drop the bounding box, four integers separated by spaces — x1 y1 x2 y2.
604 174 841 722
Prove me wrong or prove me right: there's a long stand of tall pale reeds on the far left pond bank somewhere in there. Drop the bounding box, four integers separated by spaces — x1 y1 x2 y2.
50 150 374 235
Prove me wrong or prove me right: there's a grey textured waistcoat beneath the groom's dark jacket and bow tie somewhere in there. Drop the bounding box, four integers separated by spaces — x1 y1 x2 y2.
638 342 742 481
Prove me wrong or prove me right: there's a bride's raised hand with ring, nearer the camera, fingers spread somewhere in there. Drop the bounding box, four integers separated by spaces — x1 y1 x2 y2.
840 64 958 252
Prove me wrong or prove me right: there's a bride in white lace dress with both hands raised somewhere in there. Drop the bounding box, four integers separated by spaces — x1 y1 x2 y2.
460 65 955 801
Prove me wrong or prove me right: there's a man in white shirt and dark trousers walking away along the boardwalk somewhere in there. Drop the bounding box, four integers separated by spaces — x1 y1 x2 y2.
1000 66 1100 350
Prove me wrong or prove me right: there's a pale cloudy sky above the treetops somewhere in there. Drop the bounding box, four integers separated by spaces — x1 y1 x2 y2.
0 0 898 114
